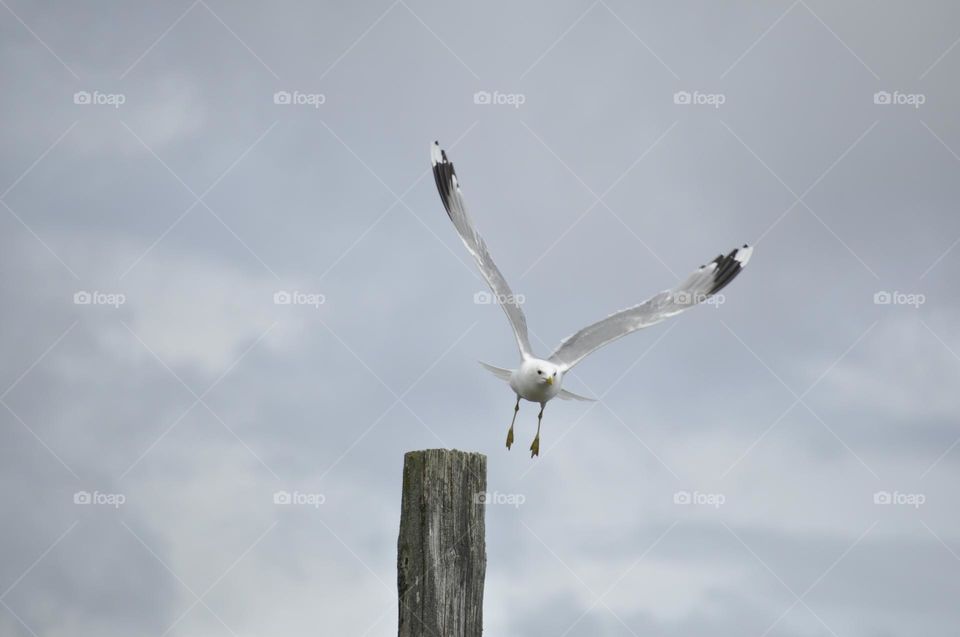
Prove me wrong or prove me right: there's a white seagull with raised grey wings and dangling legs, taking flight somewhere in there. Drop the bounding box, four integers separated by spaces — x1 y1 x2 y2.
430 142 753 458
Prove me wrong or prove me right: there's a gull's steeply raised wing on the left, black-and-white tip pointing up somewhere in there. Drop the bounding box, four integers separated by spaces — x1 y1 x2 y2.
430 142 533 358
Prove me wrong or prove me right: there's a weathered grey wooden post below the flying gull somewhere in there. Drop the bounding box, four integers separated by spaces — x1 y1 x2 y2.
397 449 487 637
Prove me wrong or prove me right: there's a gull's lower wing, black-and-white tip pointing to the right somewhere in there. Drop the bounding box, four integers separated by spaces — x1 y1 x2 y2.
549 245 753 370
